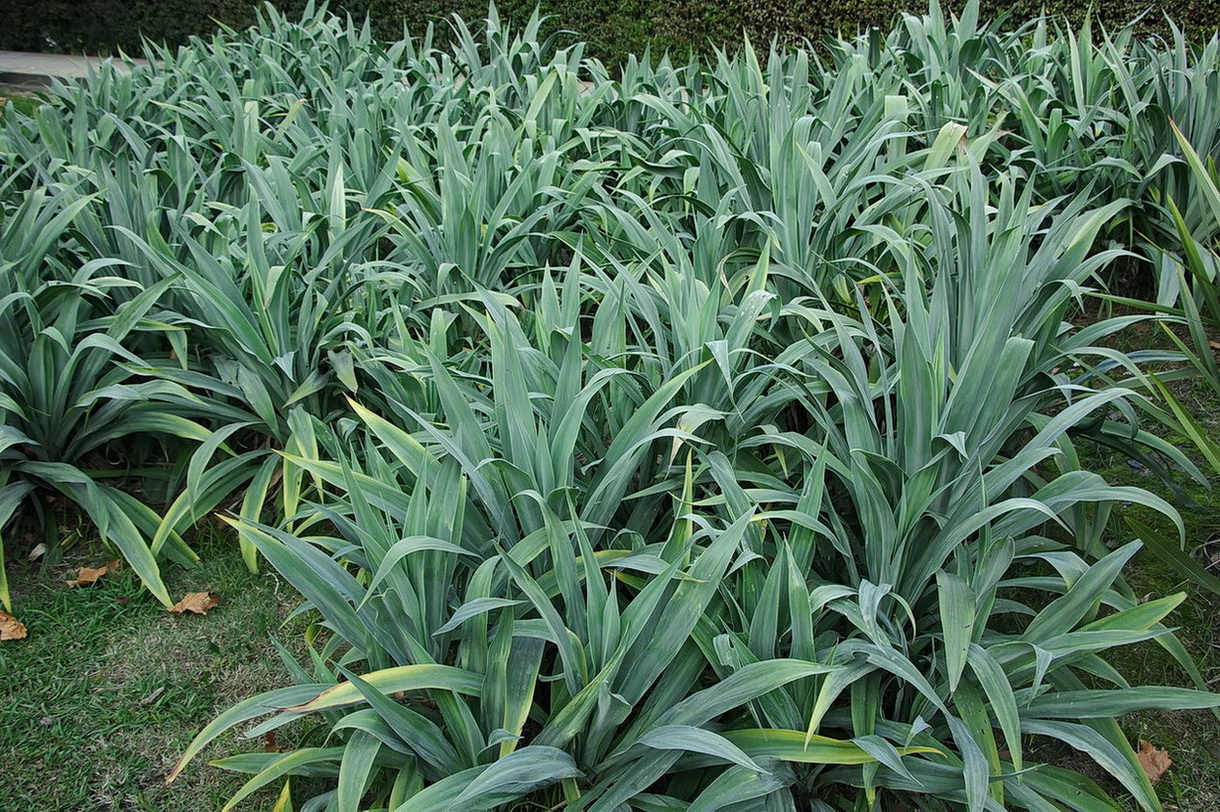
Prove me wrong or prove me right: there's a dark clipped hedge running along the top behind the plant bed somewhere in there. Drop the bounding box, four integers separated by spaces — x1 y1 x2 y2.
7 0 1220 63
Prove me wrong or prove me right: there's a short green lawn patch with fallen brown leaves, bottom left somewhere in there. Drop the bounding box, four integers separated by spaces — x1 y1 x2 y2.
0 531 319 812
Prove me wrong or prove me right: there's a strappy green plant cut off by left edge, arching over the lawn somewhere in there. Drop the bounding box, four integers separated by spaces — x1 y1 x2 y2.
0 181 206 608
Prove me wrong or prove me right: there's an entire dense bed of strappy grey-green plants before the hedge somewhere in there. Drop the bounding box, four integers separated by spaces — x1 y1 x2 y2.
7 5 1220 811
